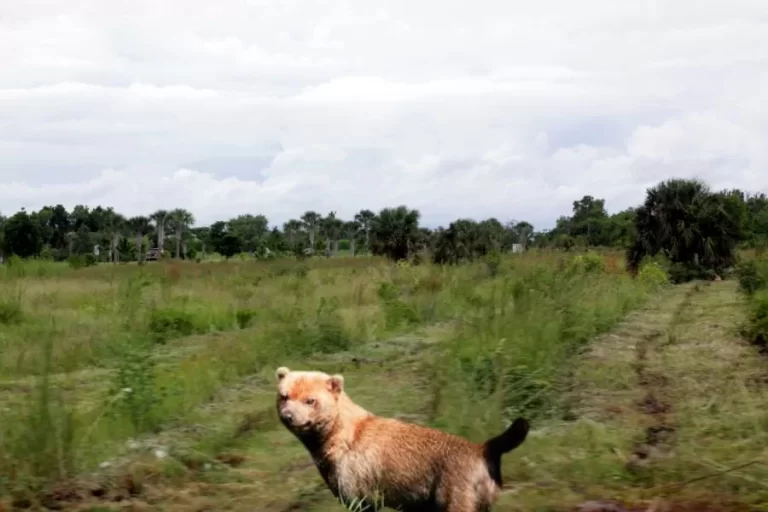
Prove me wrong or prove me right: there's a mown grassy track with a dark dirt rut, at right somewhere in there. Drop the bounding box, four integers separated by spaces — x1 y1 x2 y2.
552 282 768 510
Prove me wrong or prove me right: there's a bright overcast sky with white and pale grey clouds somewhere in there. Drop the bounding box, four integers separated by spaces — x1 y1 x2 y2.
0 0 768 228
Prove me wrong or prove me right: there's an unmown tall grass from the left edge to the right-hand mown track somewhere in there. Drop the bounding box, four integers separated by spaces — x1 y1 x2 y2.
0 252 659 502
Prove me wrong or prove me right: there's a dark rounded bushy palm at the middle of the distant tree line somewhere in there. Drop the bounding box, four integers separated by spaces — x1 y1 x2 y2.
371 205 421 261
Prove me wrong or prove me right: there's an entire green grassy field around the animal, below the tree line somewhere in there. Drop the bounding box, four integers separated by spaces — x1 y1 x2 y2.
0 252 768 512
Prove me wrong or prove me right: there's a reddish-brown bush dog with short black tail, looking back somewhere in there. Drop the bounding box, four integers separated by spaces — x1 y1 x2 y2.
277 367 528 512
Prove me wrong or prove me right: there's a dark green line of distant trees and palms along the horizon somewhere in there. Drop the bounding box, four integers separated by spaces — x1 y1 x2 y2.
0 180 768 270
